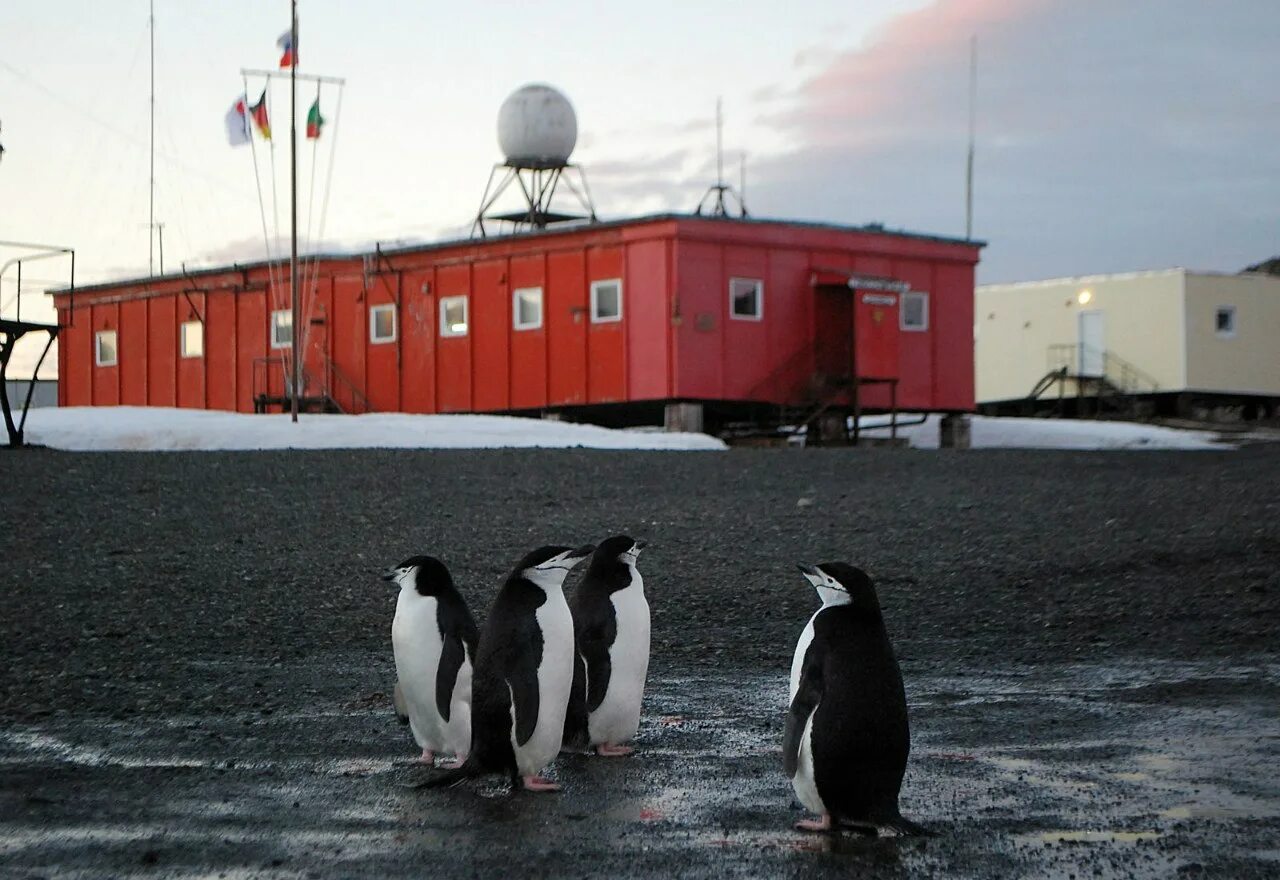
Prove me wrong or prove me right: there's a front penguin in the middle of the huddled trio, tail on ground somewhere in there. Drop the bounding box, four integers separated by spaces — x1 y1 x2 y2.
425 545 595 792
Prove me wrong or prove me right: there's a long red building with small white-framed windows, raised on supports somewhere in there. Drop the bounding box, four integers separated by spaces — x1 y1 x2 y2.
54 215 980 437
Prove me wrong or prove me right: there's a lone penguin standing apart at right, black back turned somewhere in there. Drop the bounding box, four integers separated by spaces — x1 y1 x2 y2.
782 563 929 835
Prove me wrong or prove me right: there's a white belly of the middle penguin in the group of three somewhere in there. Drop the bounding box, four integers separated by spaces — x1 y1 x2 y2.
511 590 573 776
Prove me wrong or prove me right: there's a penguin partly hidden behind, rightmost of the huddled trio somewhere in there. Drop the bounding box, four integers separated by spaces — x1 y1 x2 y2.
564 535 649 756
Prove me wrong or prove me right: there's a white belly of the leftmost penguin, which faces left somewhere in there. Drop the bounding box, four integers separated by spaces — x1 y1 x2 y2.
392 592 449 751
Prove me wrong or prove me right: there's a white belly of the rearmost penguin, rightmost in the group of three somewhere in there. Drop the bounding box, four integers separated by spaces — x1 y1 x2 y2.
586 573 649 746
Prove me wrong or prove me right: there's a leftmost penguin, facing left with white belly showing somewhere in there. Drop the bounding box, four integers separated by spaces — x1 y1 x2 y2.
383 556 477 764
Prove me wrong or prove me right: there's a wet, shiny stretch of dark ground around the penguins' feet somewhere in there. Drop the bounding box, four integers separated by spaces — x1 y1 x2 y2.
0 659 1280 877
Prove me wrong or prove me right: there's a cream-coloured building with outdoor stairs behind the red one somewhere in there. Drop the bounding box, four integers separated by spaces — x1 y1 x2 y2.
974 269 1280 412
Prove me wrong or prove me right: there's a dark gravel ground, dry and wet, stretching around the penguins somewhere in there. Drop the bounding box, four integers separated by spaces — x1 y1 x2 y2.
0 445 1280 877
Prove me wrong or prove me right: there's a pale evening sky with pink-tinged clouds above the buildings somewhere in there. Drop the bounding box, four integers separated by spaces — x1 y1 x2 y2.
0 0 1280 373
